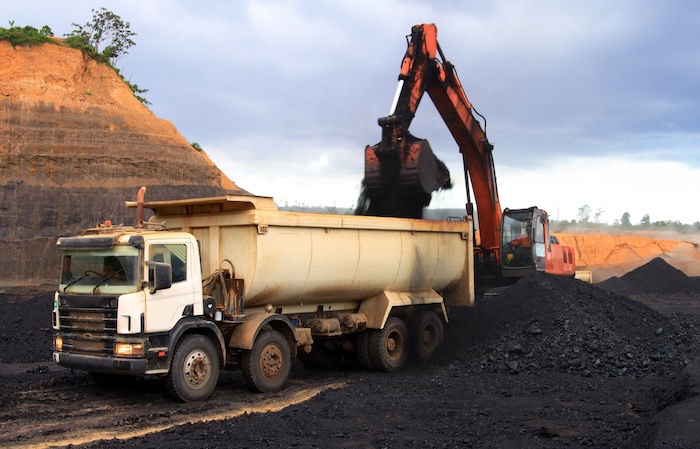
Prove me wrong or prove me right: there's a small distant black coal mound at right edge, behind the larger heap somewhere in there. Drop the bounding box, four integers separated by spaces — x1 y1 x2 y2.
598 257 700 295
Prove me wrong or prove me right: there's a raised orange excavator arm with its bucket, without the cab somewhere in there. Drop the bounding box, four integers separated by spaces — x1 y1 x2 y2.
364 24 502 266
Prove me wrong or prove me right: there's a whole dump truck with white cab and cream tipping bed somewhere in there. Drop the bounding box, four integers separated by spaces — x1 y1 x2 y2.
52 188 474 402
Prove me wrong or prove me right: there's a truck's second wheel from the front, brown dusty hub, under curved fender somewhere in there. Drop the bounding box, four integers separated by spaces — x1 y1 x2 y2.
241 331 292 393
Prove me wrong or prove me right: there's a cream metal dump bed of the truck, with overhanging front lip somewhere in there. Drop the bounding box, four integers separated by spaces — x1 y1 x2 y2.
145 195 473 310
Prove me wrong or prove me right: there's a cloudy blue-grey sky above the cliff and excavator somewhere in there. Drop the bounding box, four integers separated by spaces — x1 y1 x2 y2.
6 0 700 224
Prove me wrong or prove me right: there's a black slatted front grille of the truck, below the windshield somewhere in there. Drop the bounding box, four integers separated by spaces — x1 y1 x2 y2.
58 294 117 356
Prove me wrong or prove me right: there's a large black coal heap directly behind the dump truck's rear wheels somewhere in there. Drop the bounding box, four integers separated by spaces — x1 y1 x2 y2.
441 274 700 377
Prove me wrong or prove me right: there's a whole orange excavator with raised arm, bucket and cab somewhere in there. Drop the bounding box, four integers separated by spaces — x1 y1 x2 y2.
357 24 576 282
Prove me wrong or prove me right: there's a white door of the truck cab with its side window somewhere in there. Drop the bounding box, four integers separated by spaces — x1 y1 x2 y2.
144 239 194 332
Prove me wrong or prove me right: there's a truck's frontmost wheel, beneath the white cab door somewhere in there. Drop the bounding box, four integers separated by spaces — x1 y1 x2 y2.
165 334 219 402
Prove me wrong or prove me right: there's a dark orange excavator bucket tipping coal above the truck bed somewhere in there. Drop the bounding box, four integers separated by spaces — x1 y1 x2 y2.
364 136 451 195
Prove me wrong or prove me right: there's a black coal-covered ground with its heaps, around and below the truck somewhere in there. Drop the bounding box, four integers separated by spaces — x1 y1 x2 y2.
0 259 700 448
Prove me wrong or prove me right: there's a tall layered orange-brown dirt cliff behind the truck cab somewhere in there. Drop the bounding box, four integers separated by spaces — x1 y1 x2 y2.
0 41 245 285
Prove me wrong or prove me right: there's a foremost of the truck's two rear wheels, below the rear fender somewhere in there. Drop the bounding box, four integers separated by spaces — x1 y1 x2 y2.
369 316 408 372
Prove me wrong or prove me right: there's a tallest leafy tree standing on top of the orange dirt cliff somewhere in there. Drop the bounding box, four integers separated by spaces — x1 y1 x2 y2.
66 8 136 64
